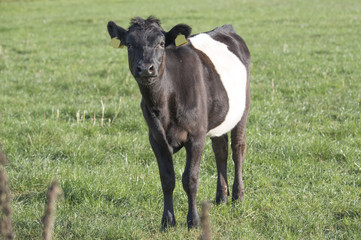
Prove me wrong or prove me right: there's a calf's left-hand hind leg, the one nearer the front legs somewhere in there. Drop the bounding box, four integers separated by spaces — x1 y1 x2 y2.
211 134 229 204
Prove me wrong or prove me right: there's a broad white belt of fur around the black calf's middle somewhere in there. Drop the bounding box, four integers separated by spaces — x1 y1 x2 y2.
189 33 247 137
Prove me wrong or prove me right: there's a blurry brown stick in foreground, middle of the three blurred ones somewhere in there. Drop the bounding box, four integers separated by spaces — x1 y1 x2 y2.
42 179 61 240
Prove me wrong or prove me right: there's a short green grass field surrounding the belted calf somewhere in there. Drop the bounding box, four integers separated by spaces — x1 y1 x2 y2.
0 0 361 239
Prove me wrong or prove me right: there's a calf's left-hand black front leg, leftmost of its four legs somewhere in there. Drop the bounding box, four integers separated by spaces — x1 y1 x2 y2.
149 133 176 228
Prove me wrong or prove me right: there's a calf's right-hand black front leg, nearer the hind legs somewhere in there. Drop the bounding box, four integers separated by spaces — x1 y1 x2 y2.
182 135 205 228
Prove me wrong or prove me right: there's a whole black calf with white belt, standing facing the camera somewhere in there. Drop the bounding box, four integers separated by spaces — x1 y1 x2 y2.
108 17 250 227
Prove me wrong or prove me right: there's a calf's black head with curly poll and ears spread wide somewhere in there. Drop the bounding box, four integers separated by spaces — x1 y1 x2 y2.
108 17 192 84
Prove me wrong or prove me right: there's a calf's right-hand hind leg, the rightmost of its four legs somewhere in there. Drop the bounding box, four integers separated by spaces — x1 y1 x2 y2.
231 119 247 201
